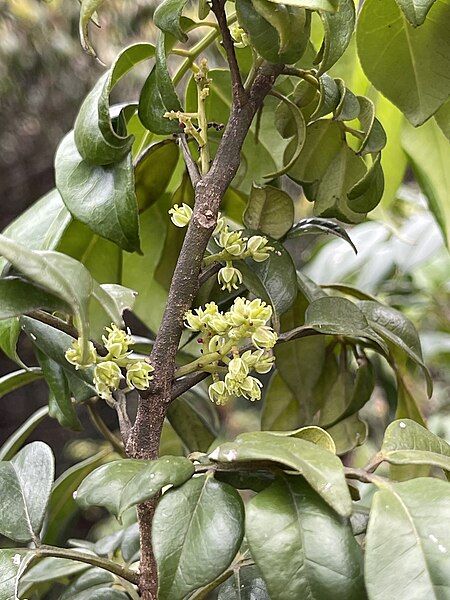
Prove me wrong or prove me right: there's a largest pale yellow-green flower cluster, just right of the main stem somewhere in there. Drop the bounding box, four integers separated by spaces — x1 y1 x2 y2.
185 297 277 404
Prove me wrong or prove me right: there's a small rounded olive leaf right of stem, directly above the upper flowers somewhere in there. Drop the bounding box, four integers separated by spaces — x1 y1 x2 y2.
244 185 294 240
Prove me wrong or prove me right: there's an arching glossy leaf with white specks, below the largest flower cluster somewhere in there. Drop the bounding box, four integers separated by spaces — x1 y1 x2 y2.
209 431 352 517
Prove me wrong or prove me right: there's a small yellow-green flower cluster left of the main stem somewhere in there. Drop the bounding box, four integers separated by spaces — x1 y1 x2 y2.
66 324 154 400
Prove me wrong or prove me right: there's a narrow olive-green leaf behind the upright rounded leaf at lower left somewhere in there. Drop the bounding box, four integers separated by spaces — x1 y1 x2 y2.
43 450 109 545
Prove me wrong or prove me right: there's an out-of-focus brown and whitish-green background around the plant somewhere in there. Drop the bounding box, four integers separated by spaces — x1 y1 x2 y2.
0 0 450 534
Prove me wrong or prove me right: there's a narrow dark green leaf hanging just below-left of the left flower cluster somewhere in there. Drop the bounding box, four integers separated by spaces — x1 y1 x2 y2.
36 350 82 431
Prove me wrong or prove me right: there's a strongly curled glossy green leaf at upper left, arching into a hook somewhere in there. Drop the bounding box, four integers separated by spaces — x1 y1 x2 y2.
74 44 155 165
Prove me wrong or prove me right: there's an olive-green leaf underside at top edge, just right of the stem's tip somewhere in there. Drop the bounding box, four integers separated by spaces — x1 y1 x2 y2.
236 0 311 64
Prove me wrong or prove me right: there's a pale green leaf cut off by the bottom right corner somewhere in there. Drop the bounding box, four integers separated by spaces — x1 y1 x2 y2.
365 478 450 600
